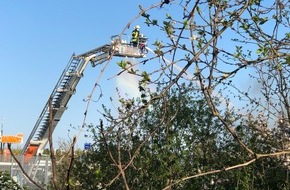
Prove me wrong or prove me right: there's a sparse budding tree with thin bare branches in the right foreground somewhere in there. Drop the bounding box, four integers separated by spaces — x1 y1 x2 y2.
82 0 289 189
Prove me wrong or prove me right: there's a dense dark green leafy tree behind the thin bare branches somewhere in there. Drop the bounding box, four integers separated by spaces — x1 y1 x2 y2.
75 83 288 189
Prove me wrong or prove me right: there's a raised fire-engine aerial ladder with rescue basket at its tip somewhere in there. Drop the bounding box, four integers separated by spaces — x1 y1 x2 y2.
21 36 147 157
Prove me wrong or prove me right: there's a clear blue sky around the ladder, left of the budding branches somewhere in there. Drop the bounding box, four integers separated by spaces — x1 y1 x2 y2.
0 0 159 148
